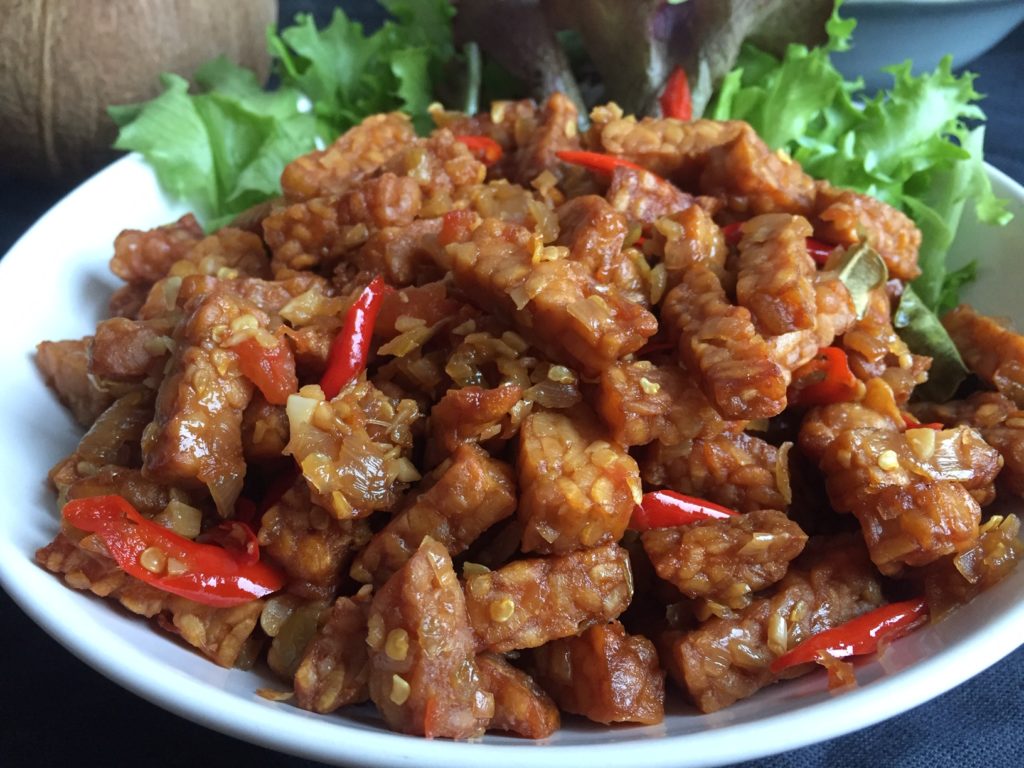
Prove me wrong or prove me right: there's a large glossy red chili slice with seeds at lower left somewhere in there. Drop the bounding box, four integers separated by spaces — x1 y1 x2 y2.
63 496 285 607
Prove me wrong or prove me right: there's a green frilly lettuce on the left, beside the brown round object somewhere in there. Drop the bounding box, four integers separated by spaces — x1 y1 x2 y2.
110 0 455 229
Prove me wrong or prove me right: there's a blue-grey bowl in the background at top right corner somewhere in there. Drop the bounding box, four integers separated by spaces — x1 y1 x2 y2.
833 0 1024 91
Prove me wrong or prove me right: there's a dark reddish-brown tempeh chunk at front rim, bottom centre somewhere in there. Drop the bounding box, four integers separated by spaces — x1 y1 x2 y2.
532 622 665 725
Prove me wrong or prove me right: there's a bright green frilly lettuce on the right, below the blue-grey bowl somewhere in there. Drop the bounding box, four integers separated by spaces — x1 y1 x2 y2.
711 2 1011 403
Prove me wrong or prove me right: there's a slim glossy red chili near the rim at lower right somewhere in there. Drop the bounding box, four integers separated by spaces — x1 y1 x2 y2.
770 598 928 675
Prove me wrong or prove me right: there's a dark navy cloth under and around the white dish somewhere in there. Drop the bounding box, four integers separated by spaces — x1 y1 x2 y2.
0 0 1024 768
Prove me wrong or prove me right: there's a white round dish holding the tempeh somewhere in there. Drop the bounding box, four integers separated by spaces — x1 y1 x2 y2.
0 157 1024 768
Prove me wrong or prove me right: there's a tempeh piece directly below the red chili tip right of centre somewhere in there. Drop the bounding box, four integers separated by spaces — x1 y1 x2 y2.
640 510 807 608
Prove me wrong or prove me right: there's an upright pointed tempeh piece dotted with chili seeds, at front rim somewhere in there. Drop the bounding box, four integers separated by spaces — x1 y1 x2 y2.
367 538 495 738
